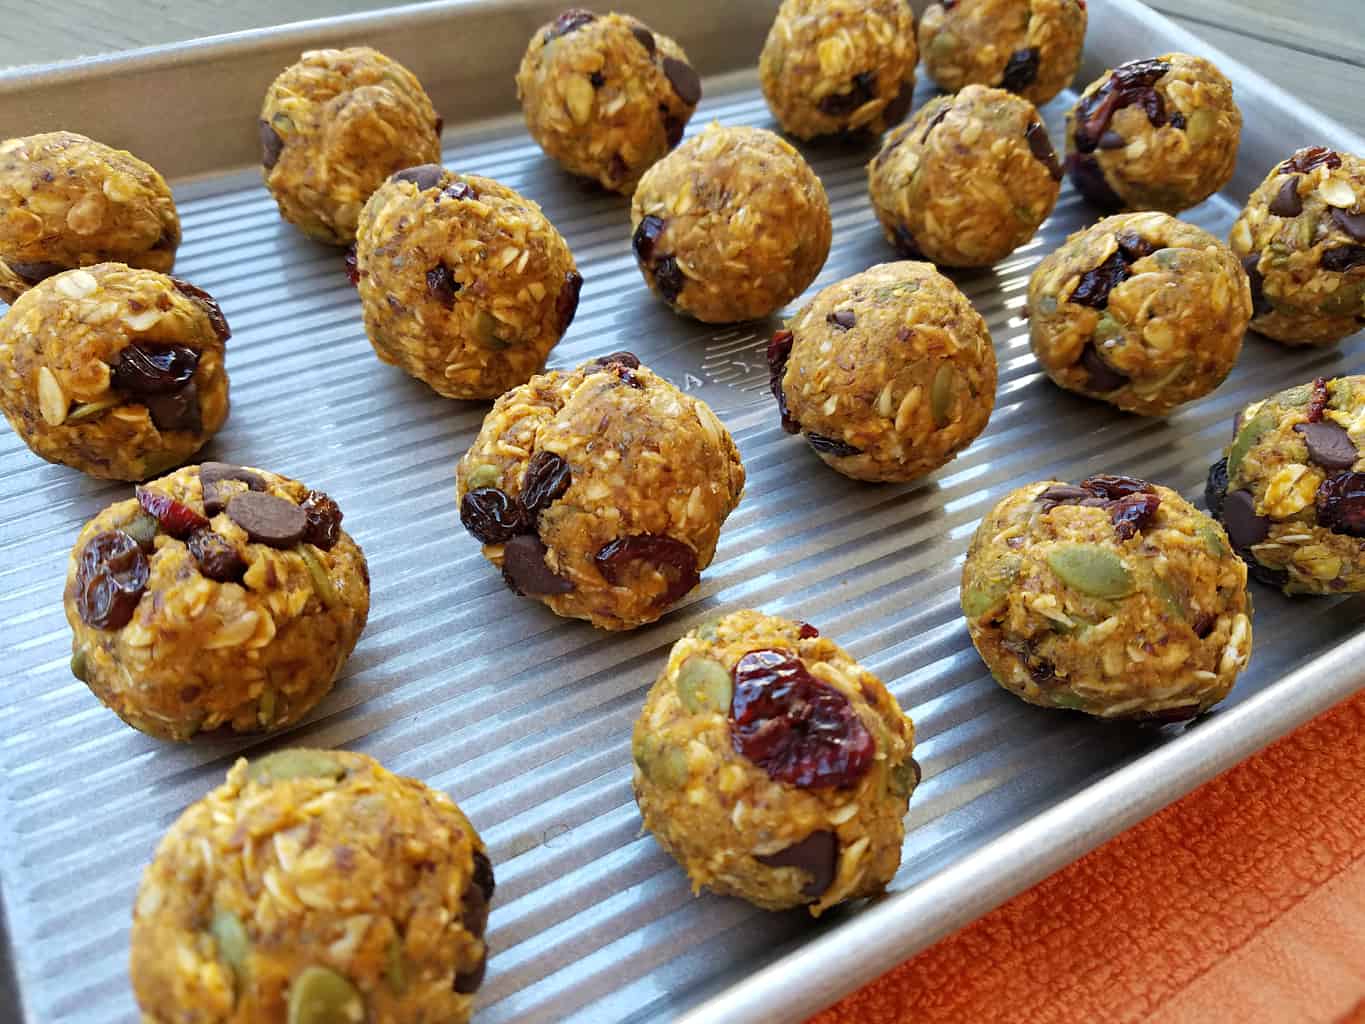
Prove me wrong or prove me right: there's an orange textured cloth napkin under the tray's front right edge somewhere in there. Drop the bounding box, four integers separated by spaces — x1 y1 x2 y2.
811 694 1365 1024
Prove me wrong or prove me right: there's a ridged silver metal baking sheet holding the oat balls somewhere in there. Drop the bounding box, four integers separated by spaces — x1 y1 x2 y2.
0 0 1365 1024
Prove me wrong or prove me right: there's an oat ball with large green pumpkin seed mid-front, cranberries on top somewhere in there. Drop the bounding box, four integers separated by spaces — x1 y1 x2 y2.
962 475 1252 722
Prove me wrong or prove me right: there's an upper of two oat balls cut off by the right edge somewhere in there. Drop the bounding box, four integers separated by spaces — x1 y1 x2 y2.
1229 146 1365 345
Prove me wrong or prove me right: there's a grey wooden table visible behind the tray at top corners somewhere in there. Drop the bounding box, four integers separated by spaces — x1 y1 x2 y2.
0 0 1365 131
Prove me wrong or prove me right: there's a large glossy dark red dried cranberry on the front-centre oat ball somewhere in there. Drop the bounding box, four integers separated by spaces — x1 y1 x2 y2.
730 650 876 789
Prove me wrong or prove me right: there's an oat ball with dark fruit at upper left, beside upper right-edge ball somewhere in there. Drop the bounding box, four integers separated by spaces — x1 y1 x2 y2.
1028 213 1252 416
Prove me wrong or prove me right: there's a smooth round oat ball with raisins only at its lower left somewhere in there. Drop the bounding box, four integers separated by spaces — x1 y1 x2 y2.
631 124 834 324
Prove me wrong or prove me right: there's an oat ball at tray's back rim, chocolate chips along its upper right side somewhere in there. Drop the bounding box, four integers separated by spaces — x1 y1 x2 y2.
516 8 702 195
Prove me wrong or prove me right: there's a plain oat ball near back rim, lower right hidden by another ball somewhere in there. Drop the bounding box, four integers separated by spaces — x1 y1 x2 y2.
261 46 441 246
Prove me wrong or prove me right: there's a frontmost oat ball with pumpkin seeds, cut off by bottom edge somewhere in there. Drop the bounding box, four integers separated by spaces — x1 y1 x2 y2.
130 748 493 1024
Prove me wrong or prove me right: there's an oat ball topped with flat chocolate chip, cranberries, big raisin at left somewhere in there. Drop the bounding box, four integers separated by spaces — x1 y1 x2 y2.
64 463 370 740
